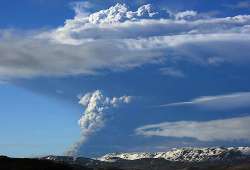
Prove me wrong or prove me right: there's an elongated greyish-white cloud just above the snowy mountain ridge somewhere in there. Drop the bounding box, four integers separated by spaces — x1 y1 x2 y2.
135 116 250 141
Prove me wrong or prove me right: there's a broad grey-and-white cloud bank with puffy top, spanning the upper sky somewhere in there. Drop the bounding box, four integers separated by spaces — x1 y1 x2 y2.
0 4 250 79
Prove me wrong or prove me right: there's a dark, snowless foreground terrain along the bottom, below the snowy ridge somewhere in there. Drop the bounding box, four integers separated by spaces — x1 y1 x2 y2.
0 156 250 170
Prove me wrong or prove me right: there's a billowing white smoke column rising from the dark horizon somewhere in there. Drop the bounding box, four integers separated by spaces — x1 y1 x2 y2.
66 90 132 155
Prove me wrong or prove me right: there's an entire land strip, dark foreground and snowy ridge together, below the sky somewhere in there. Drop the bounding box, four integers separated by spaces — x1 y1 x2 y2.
0 147 250 170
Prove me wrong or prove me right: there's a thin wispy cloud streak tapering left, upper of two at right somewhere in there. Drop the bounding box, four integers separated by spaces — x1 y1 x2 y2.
161 92 250 110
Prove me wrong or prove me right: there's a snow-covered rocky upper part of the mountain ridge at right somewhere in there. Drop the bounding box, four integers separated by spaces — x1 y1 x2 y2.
98 147 250 162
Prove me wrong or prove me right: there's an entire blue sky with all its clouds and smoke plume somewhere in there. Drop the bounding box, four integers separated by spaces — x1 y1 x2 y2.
0 0 250 157
